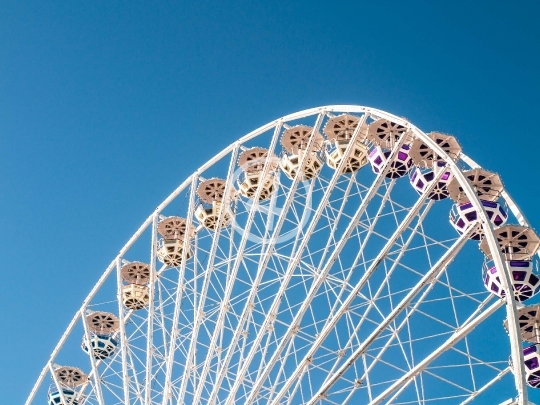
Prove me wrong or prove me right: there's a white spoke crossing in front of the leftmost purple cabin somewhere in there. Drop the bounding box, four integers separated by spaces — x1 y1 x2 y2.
246 131 405 404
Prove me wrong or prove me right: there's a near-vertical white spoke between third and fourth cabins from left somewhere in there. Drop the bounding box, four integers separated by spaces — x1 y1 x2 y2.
144 211 159 405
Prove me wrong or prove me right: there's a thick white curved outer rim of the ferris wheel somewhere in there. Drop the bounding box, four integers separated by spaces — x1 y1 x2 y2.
25 105 540 405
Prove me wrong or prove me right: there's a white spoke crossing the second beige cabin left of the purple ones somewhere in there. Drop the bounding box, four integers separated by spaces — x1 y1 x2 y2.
202 109 326 403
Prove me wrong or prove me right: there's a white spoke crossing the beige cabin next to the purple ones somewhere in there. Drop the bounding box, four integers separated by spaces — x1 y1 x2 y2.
226 110 369 405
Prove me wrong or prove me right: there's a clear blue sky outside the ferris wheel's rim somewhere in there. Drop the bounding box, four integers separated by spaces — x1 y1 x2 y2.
0 0 540 405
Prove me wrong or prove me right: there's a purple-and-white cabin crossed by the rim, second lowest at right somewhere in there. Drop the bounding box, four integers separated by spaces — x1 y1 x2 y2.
484 260 540 301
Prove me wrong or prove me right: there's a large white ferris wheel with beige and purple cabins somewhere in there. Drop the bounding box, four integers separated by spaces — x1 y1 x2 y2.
26 106 540 405
